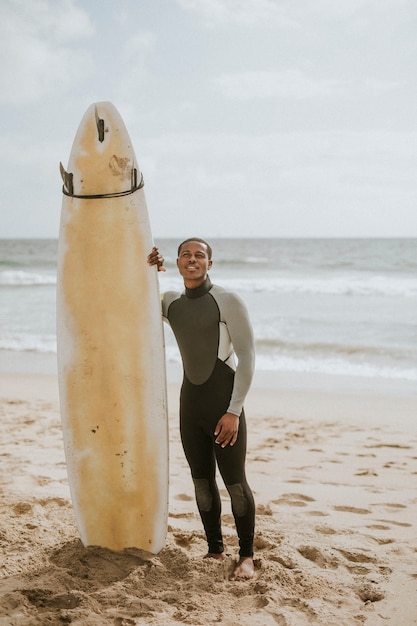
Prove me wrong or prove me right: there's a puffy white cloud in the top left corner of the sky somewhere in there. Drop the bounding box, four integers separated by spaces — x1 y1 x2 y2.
0 0 93 105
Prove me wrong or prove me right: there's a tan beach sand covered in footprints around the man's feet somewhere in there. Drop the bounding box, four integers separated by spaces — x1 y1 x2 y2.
0 372 417 626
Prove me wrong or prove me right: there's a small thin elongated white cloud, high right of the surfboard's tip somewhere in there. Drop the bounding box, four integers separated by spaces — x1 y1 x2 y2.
212 70 347 100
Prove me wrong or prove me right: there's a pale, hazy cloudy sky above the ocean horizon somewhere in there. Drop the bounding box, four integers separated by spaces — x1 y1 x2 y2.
0 0 417 238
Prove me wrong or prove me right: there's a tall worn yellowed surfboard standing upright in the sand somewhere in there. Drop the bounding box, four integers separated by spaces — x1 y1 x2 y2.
57 102 168 554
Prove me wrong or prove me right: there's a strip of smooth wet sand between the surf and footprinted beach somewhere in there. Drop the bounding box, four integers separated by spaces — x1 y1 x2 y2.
0 366 417 432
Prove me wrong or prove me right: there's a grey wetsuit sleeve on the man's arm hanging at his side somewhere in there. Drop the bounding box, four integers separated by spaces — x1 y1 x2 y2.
219 293 255 415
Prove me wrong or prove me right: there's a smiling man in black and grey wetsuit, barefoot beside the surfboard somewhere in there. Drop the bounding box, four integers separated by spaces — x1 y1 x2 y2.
148 237 255 580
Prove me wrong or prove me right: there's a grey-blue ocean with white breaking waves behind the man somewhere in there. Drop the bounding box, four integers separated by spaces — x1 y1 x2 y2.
0 239 417 381
